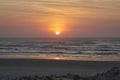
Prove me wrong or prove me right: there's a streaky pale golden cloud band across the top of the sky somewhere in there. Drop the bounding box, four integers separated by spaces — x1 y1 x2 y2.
0 0 120 16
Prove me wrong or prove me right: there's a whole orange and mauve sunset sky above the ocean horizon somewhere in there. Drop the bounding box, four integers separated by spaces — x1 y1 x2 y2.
0 0 120 37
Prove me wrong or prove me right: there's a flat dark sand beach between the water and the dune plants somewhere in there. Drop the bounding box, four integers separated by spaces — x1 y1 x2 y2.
0 59 120 76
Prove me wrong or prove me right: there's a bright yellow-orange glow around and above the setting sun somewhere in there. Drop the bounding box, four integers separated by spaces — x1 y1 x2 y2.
49 16 67 36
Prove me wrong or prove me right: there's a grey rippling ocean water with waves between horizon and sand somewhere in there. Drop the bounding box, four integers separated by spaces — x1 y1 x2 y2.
0 38 120 60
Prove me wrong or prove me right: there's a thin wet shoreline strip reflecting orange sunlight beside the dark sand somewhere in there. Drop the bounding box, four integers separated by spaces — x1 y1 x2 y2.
0 54 120 61
